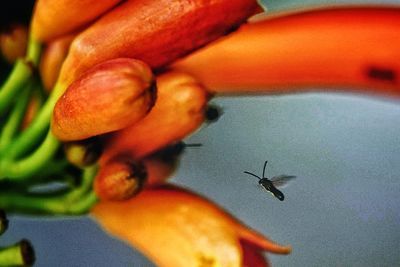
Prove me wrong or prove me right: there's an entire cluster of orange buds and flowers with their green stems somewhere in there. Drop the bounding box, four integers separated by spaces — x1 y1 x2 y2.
0 0 400 266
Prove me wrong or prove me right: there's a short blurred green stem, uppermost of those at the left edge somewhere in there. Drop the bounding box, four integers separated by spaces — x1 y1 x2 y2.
0 59 32 114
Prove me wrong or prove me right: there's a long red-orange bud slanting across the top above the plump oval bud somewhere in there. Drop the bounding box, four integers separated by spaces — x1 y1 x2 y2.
57 0 259 86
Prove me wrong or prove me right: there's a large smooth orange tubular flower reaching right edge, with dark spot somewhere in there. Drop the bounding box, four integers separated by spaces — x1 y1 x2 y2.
173 7 400 96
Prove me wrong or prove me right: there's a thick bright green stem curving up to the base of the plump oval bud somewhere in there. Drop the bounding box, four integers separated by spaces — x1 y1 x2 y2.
0 130 60 181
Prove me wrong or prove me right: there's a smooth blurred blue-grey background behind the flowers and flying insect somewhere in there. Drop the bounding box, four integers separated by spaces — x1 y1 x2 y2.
0 0 400 267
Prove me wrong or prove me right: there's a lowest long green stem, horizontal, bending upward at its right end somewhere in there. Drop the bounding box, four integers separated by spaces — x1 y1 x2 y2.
0 166 97 215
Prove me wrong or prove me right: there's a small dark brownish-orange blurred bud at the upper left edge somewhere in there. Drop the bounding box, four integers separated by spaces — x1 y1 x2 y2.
0 24 28 64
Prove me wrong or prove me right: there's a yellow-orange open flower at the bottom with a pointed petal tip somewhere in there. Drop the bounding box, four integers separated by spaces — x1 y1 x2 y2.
92 187 291 267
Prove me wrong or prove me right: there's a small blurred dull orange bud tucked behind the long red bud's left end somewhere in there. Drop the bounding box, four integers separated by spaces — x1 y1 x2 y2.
39 34 75 92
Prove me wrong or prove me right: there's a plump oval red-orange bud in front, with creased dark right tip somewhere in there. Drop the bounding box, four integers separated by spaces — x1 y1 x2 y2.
51 58 155 141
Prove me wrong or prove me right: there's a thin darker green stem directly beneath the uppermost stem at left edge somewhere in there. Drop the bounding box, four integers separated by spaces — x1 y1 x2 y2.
0 85 30 148
